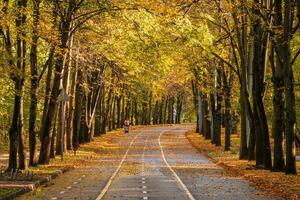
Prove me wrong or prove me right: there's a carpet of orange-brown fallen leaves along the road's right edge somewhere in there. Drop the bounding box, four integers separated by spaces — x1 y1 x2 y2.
186 130 300 200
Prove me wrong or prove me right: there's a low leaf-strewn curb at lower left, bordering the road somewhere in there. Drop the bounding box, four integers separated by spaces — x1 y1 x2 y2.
0 168 72 200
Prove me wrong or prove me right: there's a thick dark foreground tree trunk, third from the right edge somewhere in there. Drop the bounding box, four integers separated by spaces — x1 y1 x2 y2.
253 0 272 169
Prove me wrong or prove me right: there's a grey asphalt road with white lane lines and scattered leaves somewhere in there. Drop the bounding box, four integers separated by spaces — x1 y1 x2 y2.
19 126 272 200
